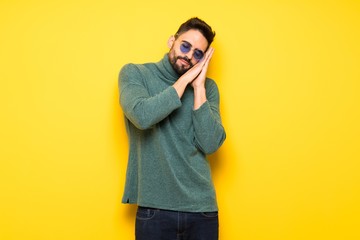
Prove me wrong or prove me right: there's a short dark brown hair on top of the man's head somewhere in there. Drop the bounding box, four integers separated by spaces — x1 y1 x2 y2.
175 17 215 46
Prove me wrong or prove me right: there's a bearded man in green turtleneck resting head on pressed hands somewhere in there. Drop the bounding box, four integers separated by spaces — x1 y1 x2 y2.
119 18 225 240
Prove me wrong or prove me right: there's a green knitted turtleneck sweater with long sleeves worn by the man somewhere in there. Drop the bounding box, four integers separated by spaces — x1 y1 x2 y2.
119 54 225 212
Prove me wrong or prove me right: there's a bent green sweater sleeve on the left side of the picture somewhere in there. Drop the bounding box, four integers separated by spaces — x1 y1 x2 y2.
119 64 181 130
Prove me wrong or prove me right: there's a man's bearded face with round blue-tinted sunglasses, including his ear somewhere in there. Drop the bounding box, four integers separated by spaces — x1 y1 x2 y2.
168 29 208 75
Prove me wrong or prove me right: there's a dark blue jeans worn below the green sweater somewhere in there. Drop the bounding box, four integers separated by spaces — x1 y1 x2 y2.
135 207 219 240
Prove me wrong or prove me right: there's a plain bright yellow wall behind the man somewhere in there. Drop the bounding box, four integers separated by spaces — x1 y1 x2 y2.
0 0 360 240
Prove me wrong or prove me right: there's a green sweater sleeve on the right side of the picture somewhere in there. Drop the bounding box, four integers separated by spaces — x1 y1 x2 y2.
192 79 226 154
